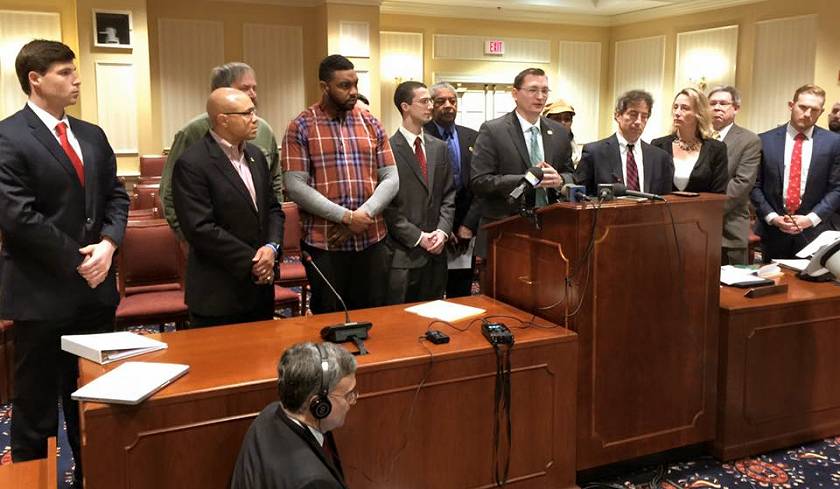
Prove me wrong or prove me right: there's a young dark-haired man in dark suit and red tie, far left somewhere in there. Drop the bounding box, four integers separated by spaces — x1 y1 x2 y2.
0 40 129 487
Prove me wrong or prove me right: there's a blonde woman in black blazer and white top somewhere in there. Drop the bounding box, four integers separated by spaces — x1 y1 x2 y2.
651 88 729 194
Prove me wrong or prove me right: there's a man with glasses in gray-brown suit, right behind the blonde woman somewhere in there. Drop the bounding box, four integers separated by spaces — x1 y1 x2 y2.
709 86 761 265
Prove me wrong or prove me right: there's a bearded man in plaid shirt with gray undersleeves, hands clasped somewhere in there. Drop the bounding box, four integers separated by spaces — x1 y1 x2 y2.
281 54 399 313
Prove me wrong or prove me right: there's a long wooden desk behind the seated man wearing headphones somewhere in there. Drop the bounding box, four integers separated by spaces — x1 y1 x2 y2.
80 296 577 489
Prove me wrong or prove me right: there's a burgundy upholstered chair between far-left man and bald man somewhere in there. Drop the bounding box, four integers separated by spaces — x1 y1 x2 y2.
116 219 188 331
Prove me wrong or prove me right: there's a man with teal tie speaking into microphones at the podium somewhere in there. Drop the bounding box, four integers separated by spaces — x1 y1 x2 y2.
471 68 574 257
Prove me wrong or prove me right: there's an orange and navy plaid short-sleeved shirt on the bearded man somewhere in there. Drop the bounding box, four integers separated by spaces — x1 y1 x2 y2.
281 104 394 251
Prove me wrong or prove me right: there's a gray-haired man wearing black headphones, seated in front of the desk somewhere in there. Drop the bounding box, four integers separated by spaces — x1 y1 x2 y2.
231 343 358 489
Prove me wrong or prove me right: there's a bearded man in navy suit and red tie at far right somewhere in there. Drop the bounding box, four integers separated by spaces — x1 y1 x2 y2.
751 85 840 262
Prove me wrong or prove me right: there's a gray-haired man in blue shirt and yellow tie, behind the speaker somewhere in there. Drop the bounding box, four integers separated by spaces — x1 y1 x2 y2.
423 82 481 297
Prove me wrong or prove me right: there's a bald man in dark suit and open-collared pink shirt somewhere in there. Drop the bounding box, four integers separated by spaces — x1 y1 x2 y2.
172 88 284 327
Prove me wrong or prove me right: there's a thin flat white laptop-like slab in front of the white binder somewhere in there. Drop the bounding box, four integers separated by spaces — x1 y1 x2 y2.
70 362 190 405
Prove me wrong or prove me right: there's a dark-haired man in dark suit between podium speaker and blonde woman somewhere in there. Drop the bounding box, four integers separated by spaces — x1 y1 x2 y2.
575 90 674 195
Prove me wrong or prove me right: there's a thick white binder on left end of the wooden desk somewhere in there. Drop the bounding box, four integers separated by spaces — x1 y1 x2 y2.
61 331 166 365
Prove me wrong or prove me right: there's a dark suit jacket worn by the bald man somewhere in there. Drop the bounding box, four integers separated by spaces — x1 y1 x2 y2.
172 132 284 316
